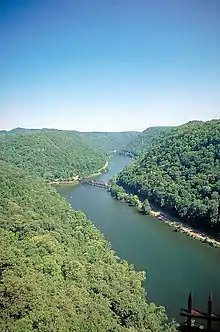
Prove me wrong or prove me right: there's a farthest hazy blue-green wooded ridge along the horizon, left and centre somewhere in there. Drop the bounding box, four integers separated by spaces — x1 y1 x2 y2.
0 128 141 153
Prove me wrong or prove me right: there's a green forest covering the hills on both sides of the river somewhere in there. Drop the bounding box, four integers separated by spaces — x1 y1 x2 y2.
0 120 220 332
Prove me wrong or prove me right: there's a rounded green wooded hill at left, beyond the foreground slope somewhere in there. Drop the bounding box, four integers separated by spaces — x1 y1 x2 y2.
0 131 106 181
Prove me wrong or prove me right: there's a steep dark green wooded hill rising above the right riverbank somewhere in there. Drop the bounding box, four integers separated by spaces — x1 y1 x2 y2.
118 120 220 232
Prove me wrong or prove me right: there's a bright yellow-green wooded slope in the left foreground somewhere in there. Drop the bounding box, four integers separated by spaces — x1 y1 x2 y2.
0 161 174 332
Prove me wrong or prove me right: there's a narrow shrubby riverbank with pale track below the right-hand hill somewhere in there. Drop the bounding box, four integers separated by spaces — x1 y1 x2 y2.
109 182 220 248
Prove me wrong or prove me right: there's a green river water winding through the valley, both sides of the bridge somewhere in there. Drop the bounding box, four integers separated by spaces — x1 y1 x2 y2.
57 156 220 320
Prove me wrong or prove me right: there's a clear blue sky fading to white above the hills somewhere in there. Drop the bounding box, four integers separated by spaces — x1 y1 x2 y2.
0 0 220 131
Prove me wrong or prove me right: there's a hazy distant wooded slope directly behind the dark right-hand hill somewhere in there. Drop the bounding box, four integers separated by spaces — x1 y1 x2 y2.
124 127 174 155
